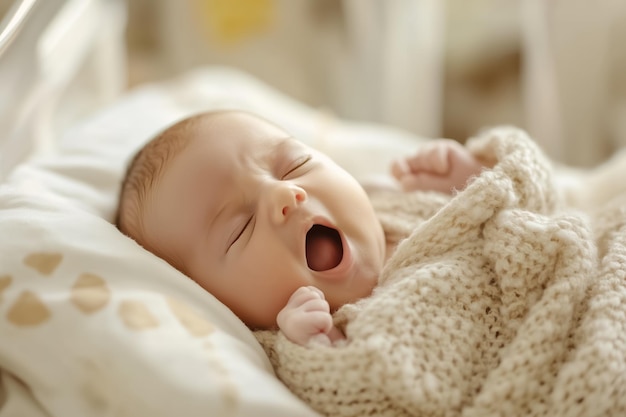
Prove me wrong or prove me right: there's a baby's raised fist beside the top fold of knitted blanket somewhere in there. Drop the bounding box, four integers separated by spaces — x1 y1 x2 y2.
391 139 483 194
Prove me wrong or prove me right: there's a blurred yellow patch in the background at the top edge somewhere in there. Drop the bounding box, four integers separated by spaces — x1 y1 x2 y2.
192 0 275 44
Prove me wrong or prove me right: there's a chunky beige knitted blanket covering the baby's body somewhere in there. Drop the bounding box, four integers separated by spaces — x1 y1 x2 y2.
257 128 626 417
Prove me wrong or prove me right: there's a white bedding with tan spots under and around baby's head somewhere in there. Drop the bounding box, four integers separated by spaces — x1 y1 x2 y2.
0 68 420 417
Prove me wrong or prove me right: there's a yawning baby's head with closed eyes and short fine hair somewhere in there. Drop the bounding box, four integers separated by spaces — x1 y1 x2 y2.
117 111 385 328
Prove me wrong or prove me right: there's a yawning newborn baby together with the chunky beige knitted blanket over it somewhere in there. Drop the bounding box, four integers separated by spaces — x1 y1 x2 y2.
118 111 626 417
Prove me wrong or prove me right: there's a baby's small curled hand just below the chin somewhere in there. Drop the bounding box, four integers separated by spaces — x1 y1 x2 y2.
276 287 345 346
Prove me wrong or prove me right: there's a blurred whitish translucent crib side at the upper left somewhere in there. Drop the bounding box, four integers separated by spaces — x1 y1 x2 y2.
0 0 126 182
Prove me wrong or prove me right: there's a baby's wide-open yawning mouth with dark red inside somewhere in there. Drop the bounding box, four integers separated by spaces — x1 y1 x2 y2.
306 224 343 271
